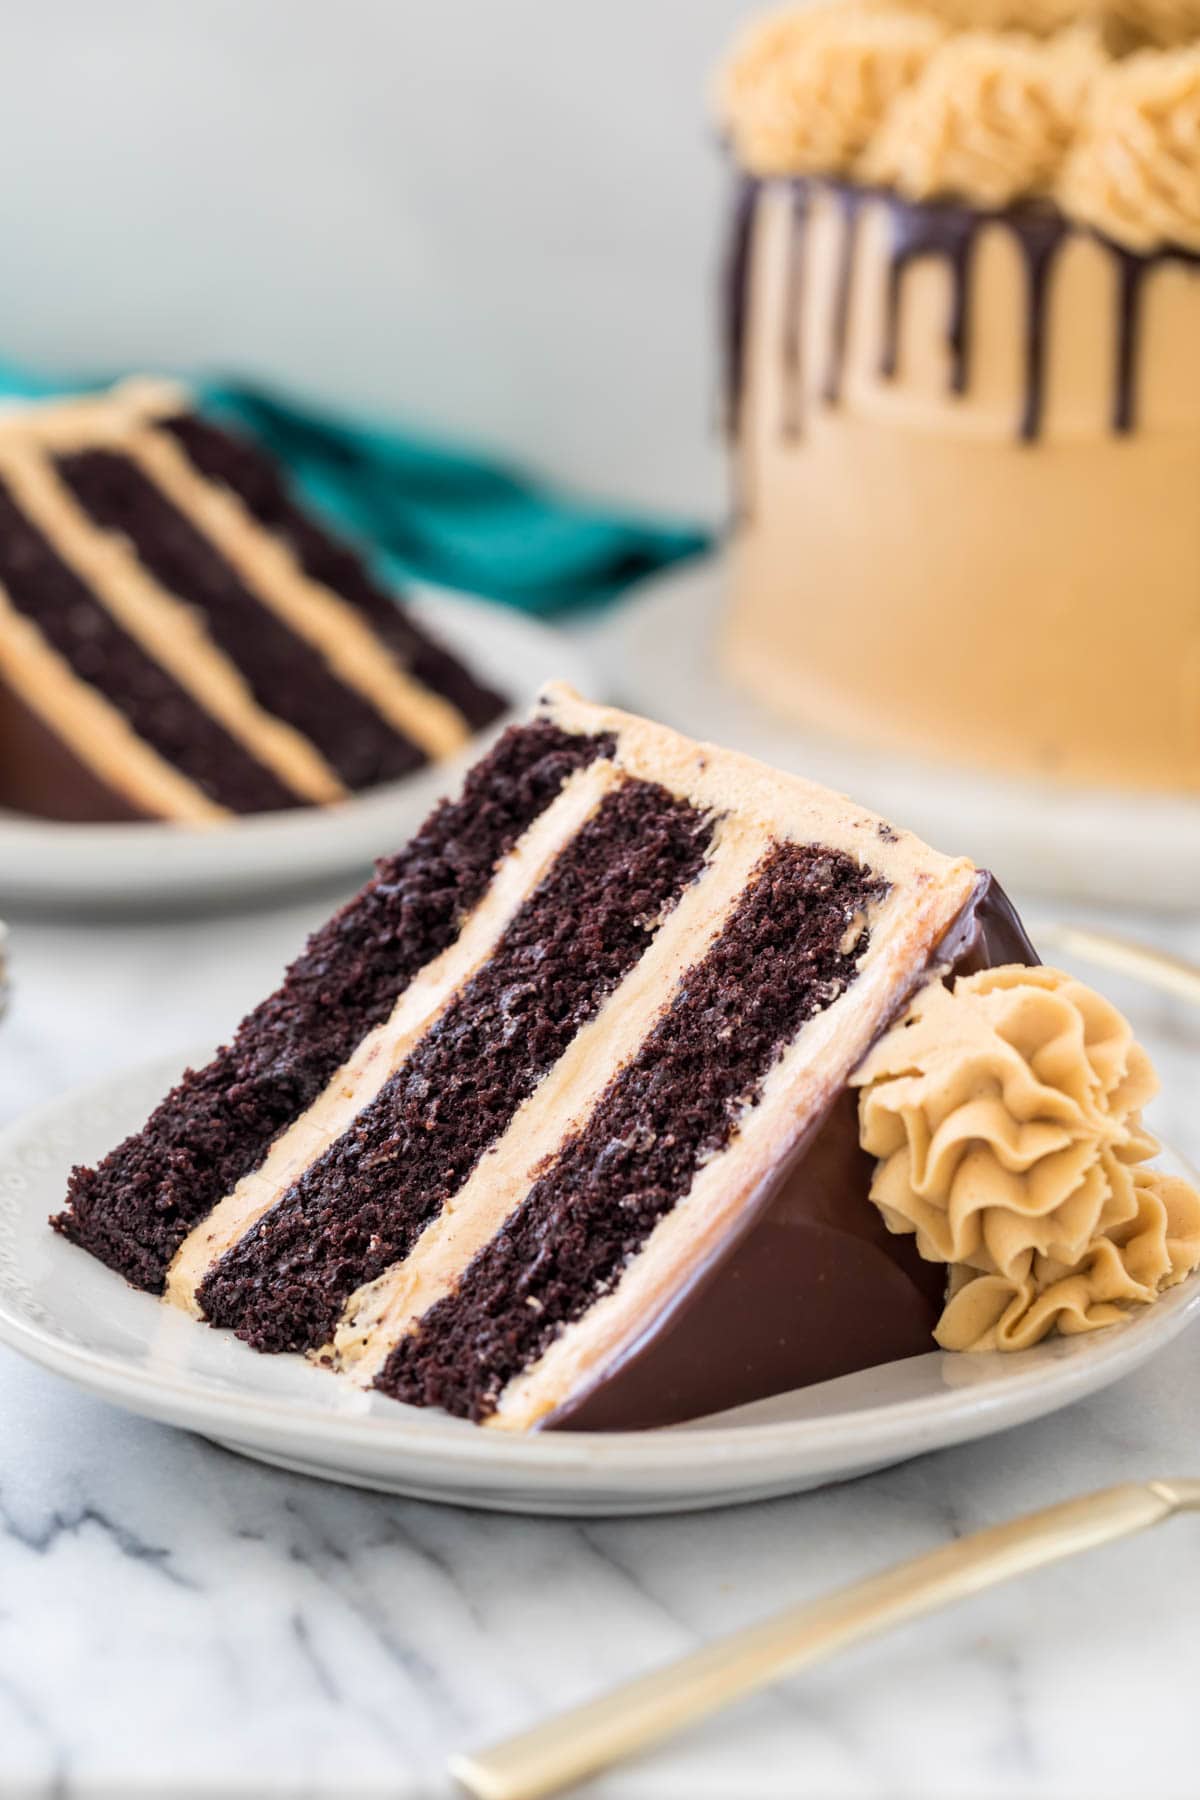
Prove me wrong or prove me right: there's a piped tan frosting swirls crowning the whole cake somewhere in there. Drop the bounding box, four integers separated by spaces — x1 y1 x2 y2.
718 0 1200 252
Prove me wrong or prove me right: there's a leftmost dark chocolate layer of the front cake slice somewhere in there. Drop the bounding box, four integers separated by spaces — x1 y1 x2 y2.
54 722 613 1292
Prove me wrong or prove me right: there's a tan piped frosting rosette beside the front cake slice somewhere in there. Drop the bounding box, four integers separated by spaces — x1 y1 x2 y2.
855 967 1200 1350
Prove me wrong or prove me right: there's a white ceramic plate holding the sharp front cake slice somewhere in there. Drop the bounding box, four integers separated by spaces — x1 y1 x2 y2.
0 1058 1200 1514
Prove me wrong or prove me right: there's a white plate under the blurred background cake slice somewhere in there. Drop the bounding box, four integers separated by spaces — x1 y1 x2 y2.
0 585 599 911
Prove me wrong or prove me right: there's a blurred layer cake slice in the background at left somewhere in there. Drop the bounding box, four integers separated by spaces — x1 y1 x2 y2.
0 382 502 824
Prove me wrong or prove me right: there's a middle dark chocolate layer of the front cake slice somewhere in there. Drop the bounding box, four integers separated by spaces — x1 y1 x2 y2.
196 781 712 1350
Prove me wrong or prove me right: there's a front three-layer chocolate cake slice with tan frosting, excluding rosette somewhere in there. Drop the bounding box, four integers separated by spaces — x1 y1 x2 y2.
56 688 1200 1429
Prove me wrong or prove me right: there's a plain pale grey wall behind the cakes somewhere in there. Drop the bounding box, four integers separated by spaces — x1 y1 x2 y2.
0 0 747 515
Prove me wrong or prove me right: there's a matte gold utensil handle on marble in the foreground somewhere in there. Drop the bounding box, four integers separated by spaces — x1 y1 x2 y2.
450 1481 1200 1800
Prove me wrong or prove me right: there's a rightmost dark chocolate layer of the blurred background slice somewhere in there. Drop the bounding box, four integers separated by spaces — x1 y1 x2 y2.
160 412 504 731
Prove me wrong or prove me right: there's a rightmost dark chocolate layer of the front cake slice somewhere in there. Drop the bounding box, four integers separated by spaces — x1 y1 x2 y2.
378 844 883 1420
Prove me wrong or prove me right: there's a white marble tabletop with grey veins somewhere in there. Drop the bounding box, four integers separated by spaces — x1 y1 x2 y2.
0 867 1200 1800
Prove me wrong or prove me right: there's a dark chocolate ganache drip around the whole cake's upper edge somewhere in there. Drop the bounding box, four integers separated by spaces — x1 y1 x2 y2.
725 175 1200 443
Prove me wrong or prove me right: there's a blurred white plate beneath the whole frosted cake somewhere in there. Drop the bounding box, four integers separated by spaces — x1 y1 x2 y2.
601 556 1200 911
